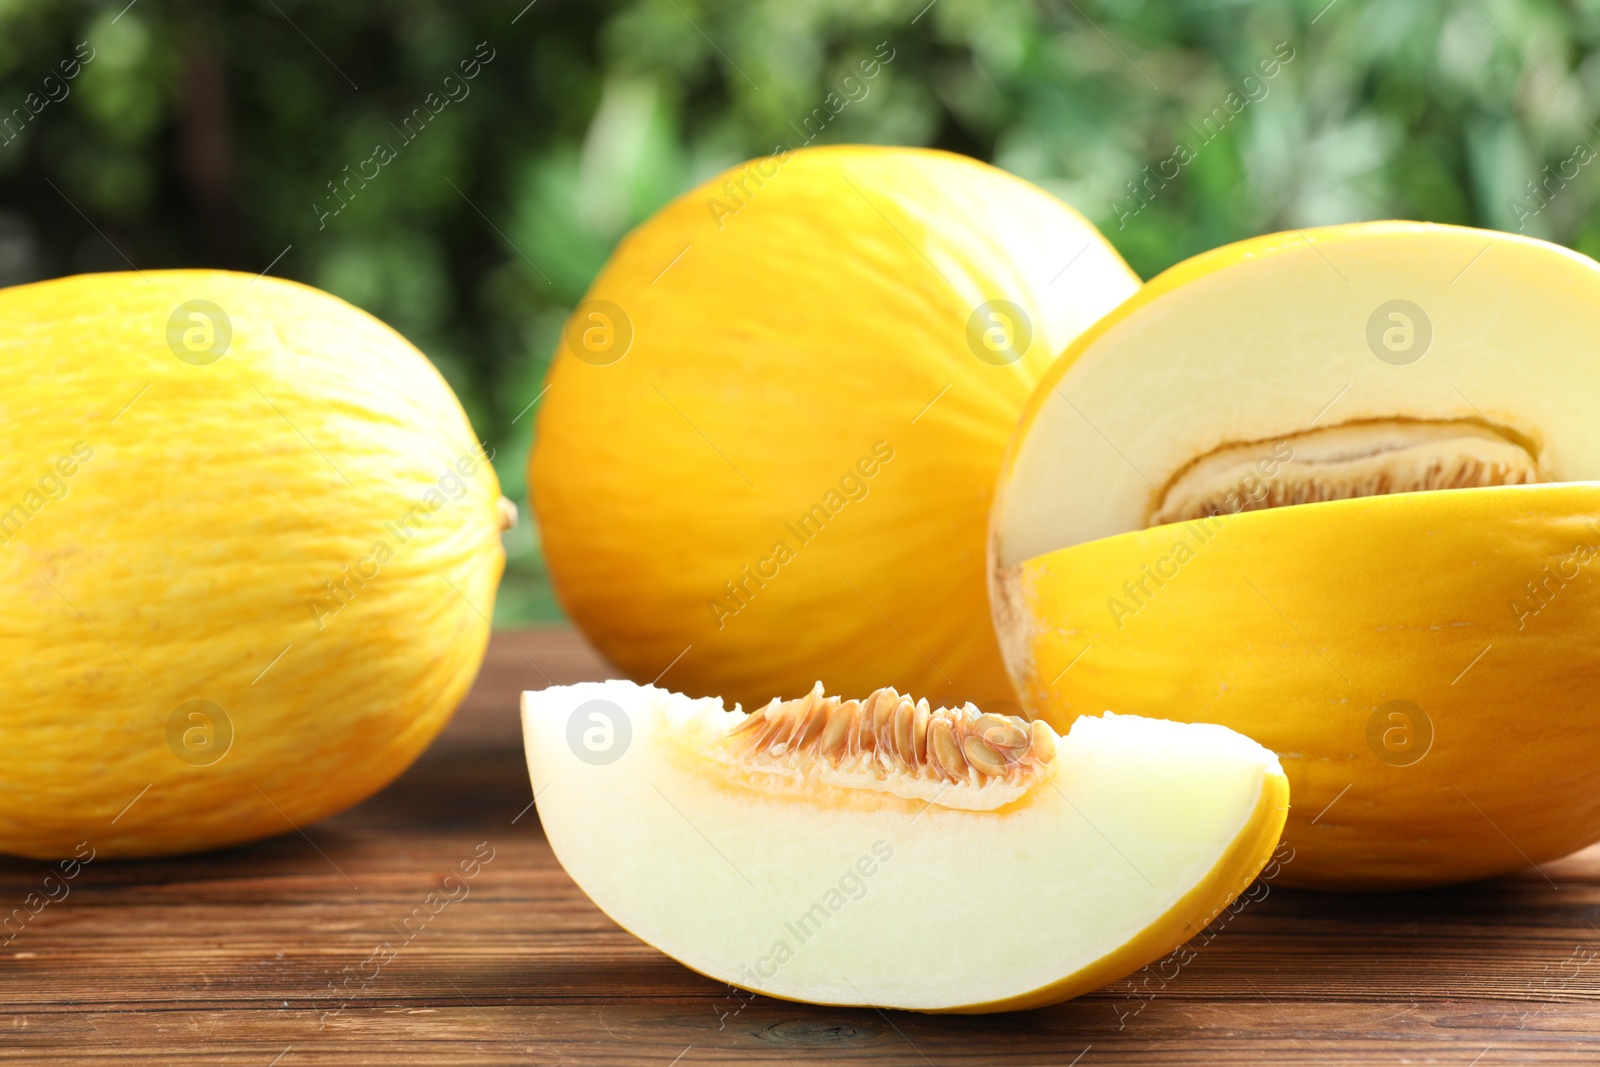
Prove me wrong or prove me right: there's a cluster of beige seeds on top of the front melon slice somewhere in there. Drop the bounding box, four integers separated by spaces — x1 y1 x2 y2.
728 681 1056 785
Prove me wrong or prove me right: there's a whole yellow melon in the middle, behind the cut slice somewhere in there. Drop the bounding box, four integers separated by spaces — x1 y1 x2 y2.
530 147 1138 704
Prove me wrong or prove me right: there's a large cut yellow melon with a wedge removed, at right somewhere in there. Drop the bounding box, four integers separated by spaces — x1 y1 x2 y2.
992 222 1600 889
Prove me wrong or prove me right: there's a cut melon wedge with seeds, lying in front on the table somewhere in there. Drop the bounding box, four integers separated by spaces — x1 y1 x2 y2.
523 681 1288 1013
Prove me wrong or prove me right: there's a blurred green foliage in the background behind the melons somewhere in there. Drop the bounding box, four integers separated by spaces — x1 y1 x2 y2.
0 0 1600 621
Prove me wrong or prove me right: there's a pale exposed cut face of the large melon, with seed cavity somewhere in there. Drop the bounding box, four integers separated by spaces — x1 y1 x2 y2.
992 222 1600 568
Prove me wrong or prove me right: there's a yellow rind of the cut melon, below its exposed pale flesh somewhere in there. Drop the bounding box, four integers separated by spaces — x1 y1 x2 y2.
1011 483 1600 889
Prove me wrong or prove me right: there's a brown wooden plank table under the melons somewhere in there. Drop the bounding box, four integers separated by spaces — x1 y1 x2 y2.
0 630 1600 1067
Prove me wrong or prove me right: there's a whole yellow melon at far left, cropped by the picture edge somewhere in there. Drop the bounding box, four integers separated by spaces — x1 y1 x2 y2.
0 270 504 857
